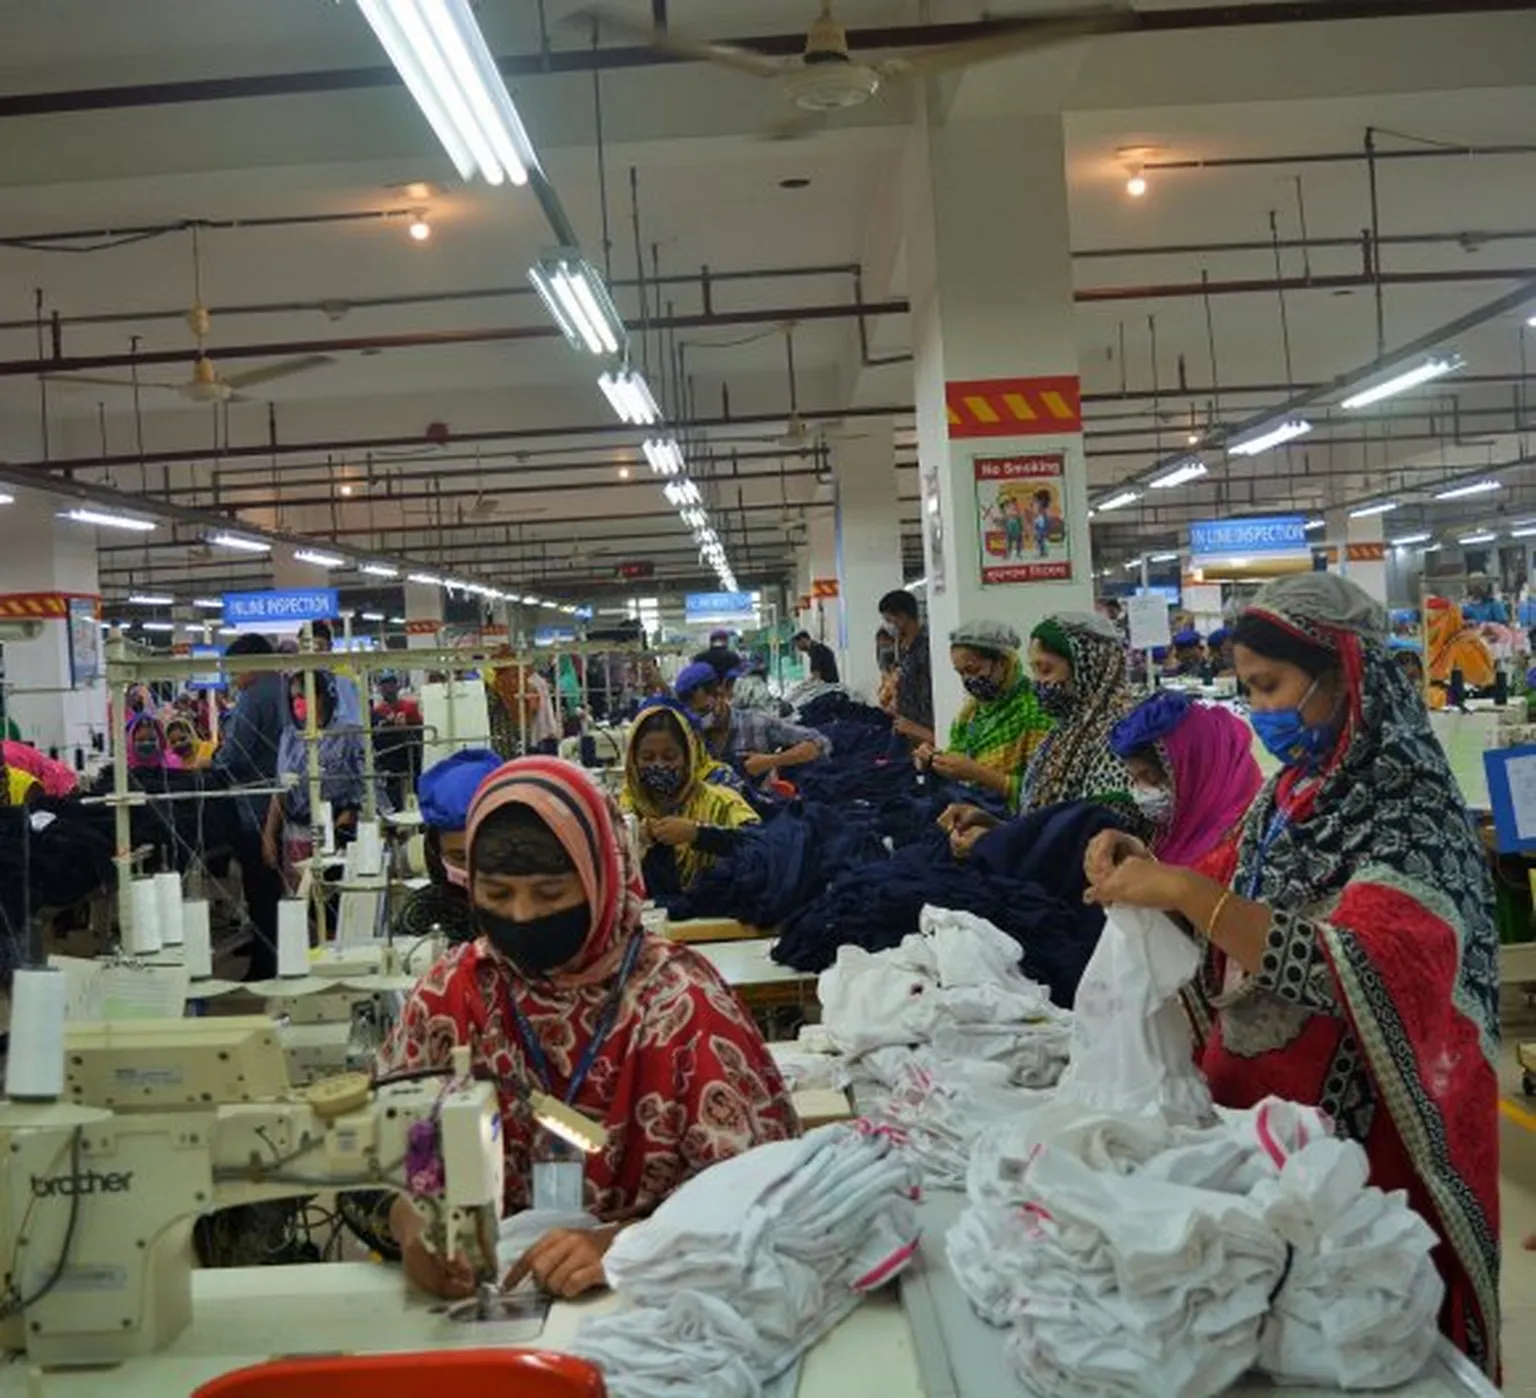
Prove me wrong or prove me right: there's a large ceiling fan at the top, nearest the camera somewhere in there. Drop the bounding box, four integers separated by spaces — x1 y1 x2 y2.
578 0 1137 140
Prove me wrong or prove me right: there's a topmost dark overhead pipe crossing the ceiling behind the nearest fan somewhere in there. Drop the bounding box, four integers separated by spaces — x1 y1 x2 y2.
0 0 1530 118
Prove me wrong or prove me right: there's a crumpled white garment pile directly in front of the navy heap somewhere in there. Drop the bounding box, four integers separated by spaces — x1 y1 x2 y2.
817 908 1071 1088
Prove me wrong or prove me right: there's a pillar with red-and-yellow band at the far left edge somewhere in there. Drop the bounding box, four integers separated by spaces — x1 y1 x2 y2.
0 490 106 759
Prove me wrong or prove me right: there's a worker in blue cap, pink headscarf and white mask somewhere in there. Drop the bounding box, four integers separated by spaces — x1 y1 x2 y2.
1109 690 1264 868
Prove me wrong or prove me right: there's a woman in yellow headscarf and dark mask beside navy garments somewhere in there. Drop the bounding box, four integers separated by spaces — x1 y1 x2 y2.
622 701 757 897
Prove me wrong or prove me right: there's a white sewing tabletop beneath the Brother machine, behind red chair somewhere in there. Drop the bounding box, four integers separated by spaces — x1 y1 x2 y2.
0 1263 923 1398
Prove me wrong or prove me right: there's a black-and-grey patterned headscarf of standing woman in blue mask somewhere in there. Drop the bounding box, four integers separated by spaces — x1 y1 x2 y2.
1235 573 1499 1055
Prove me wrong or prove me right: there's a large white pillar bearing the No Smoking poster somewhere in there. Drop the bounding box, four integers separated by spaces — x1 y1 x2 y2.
906 105 1094 733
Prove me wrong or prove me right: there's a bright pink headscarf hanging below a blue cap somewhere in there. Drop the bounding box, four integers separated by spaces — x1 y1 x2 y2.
1155 704 1264 865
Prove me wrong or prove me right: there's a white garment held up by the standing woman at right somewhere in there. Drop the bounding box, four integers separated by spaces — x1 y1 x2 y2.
1058 906 1212 1125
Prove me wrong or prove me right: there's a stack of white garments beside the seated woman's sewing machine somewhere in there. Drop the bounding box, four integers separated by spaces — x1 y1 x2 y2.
573 1126 917 1398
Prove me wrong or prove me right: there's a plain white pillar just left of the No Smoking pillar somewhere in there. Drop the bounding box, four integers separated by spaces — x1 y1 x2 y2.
833 418 906 699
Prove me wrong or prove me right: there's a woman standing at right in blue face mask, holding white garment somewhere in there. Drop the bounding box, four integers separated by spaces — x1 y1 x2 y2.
1087 573 1499 1375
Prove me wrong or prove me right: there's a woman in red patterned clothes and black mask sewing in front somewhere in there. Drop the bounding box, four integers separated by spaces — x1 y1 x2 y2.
378 757 799 1298
